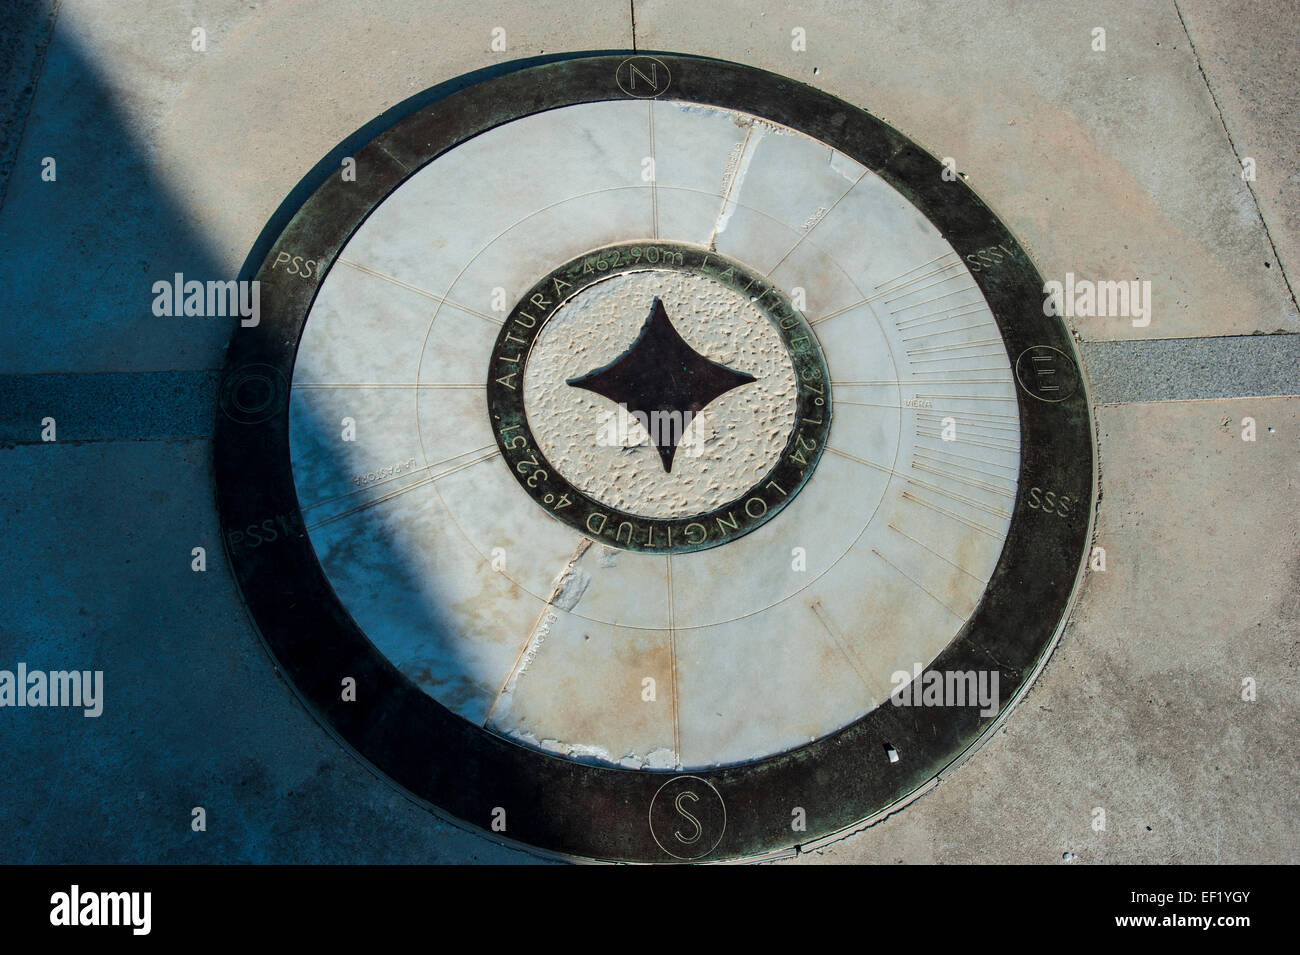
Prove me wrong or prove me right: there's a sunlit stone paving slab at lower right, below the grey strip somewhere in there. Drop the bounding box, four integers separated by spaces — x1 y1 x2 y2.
780 398 1300 864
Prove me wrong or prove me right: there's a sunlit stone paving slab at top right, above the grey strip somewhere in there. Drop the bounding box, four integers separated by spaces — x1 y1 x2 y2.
636 0 1300 339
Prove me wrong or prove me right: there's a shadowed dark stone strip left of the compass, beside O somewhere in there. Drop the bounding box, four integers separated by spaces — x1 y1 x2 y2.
0 372 221 446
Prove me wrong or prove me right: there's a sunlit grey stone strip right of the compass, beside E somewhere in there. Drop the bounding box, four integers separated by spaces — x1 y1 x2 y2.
1079 335 1300 404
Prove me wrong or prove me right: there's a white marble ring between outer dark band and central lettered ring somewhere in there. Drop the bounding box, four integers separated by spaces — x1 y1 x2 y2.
290 99 1021 769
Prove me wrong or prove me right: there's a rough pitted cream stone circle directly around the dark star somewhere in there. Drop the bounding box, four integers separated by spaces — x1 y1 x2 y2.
524 269 798 517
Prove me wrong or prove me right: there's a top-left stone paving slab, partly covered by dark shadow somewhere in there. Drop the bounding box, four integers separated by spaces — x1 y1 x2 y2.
0 0 631 374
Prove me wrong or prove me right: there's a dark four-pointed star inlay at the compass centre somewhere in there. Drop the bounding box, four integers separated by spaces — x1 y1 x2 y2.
567 298 758 472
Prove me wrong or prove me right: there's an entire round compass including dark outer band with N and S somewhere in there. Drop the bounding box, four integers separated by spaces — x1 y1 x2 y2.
215 55 1093 861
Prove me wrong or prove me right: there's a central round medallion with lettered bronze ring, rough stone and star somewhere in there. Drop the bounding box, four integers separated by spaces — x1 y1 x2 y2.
488 242 831 554
